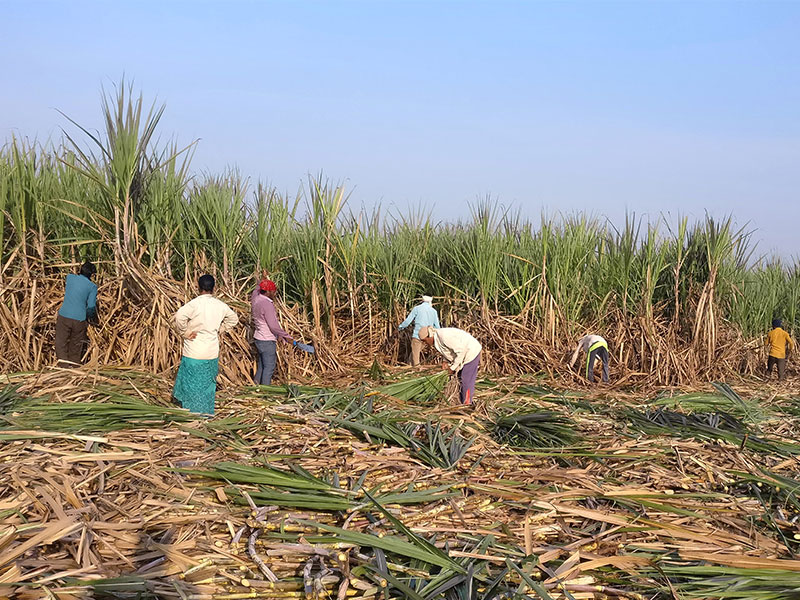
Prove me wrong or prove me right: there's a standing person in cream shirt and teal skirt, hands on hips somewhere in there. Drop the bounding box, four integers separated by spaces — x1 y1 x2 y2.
172 275 239 415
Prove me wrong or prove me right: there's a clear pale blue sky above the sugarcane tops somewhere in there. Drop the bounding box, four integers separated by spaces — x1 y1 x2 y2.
0 0 800 256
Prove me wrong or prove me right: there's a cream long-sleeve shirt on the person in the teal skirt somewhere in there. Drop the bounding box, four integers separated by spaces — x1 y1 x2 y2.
175 294 239 360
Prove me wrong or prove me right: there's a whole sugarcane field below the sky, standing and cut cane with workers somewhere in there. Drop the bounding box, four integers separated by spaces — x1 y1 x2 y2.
0 81 800 600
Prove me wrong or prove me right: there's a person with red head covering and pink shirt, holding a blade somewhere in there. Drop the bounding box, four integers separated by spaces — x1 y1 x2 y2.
250 278 294 385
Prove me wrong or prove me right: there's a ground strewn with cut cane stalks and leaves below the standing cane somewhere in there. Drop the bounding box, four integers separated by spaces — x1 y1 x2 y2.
0 363 800 600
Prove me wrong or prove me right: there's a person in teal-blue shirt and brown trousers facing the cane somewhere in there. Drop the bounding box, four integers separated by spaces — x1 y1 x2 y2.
56 260 97 367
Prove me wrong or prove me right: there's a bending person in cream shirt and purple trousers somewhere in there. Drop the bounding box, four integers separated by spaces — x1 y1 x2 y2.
419 326 482 405
